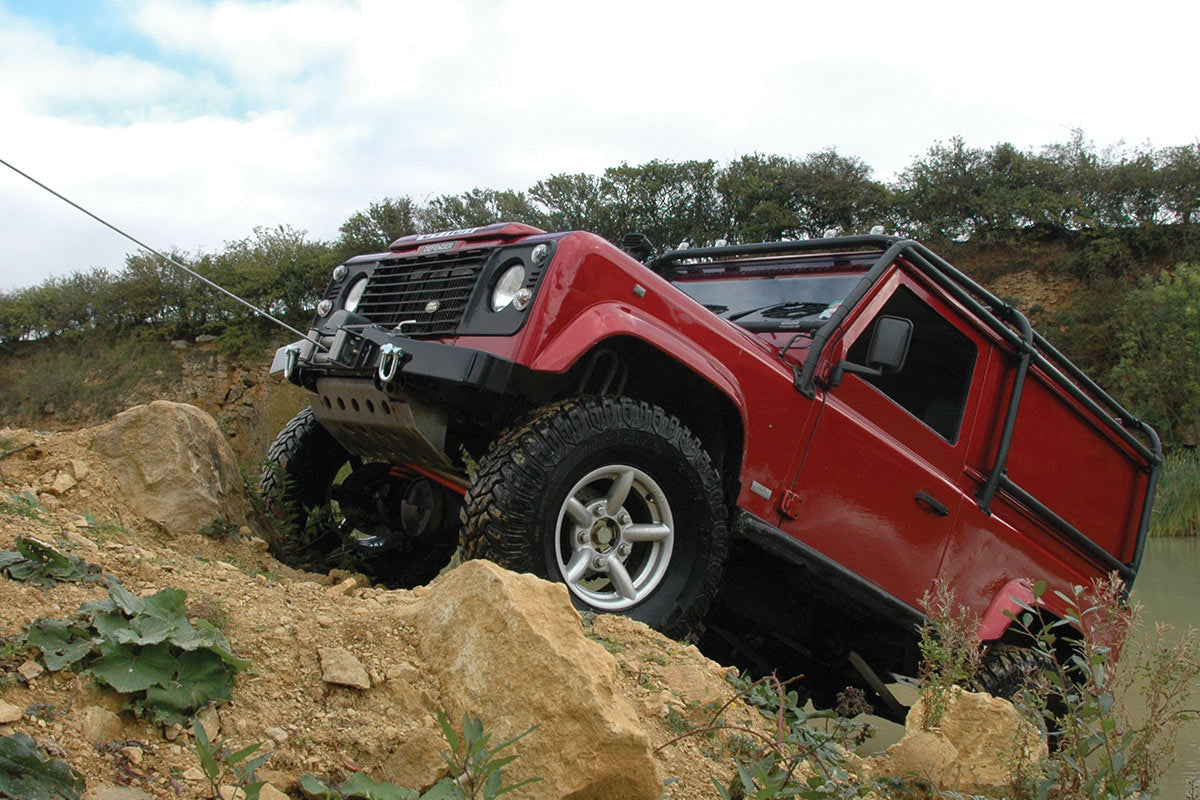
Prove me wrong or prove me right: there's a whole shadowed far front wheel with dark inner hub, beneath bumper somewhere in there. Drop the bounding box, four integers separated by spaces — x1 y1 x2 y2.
260 409 461 588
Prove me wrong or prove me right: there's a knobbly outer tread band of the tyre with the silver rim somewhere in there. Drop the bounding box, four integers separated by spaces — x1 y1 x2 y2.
461 397 728 638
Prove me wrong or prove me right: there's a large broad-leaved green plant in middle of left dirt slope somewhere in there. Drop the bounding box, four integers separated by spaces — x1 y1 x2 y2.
26 579 250 724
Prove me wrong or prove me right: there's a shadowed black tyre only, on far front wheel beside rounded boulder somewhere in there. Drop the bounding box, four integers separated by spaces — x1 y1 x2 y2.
259 408 457 588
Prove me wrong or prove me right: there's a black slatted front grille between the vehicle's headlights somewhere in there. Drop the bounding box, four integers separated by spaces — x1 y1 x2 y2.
356 248 490 337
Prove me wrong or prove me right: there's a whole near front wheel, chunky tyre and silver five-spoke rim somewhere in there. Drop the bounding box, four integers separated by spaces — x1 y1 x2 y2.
462 397 728 638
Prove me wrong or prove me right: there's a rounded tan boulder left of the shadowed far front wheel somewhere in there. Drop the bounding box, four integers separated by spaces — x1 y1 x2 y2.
91 401 246 534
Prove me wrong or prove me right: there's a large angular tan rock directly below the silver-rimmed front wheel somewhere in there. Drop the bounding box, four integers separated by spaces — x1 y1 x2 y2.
412 561 662 800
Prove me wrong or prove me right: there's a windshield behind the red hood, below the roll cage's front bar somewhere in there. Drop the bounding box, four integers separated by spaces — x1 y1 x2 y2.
674 272 862 330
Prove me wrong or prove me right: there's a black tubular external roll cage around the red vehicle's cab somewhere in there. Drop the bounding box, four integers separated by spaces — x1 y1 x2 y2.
647 234 1163 584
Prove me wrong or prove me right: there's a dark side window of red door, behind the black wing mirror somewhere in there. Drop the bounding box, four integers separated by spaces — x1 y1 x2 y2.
847 285 976 443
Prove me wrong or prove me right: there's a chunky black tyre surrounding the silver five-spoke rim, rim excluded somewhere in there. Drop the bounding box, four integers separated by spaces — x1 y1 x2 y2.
461 397 728 638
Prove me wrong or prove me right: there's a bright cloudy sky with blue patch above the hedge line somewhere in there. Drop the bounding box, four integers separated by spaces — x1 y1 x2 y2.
0 0 1200 290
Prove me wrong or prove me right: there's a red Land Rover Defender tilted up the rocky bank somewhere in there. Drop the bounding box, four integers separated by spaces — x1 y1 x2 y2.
263 223 1160 717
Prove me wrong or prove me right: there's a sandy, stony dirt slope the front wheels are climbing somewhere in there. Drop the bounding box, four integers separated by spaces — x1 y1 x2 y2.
0 429 768 799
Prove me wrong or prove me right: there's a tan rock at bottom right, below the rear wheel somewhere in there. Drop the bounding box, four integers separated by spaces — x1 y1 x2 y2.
869 688 1046 793
